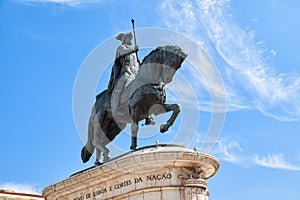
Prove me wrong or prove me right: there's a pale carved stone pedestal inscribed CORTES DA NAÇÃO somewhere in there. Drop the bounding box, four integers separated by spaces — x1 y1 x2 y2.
43 145 219 200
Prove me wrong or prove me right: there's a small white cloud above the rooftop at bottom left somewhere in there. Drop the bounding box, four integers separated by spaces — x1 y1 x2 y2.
0 182 38 194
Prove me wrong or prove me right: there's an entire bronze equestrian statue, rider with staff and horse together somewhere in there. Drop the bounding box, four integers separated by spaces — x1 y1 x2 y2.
81 20 187 165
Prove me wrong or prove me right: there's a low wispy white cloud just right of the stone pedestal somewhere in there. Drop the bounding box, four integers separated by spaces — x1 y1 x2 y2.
213 138 300 171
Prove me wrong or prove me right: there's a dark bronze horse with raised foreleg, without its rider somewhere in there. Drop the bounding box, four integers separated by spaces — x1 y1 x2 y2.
81 45 187 165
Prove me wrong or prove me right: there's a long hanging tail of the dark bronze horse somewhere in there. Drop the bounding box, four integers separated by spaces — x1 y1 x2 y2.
81 106 96 163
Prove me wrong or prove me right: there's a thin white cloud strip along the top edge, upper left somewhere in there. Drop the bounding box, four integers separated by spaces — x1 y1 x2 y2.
16 0 102 7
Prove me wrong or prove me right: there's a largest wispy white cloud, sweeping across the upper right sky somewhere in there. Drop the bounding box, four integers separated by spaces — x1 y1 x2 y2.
160 0 300 121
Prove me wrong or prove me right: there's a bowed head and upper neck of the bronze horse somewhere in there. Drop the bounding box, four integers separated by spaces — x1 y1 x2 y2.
142 45 187 83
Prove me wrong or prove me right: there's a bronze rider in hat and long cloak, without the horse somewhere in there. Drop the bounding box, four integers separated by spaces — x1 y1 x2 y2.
108 32 155 125
